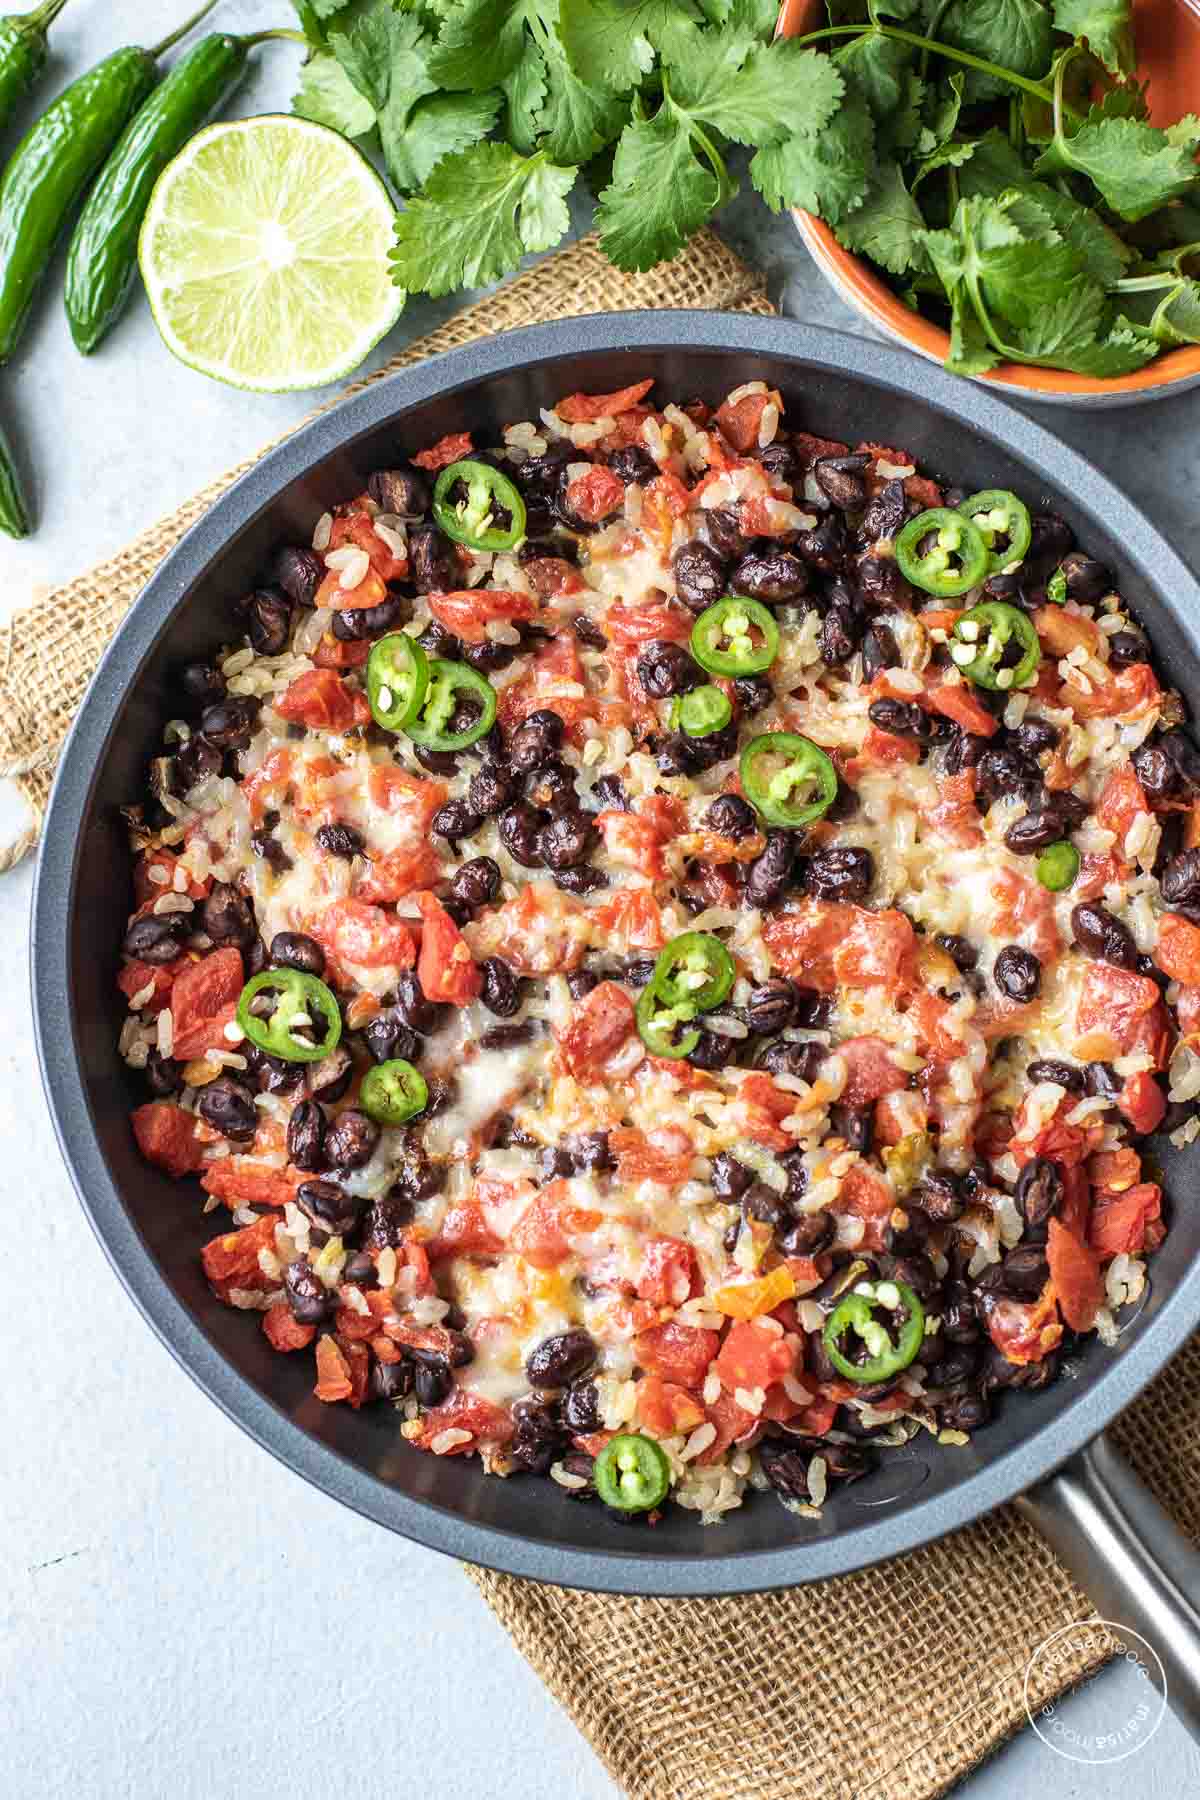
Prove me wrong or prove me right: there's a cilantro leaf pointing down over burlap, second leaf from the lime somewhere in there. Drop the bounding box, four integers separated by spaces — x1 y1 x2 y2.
596 106 721 270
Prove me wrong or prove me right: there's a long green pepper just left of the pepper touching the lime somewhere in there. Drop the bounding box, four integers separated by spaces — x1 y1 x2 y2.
0 0 216 362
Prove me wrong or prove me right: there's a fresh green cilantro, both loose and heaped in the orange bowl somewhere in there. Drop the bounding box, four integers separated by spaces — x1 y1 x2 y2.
295 0 1200 376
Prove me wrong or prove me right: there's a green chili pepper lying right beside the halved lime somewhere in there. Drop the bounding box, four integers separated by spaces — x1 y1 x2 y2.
67 31 293 356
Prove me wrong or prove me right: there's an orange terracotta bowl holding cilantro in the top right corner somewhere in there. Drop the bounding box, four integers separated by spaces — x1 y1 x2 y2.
779 0 1200 407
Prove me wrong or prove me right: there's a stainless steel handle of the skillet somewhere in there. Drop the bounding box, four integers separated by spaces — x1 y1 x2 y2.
1016 1436 1200 1739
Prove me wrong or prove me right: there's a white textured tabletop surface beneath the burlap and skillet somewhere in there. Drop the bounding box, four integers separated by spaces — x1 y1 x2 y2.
0 0 1200 1800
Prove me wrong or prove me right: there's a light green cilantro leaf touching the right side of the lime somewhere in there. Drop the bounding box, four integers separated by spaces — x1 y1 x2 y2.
390 144 578 295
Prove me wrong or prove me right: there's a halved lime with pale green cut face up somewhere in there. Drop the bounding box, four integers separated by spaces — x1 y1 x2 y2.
139 113 405 394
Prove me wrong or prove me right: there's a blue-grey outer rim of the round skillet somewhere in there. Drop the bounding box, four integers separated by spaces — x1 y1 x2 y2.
31 310 1200 1595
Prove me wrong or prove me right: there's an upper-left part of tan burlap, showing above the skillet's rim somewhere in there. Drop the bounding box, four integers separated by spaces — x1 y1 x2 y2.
0 232 772 871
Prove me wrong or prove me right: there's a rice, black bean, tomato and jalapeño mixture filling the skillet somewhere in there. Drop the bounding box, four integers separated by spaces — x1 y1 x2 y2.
117 382 1200 1523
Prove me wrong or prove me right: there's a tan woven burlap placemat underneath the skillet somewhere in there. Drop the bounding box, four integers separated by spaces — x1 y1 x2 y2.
0 232 1200 1800
